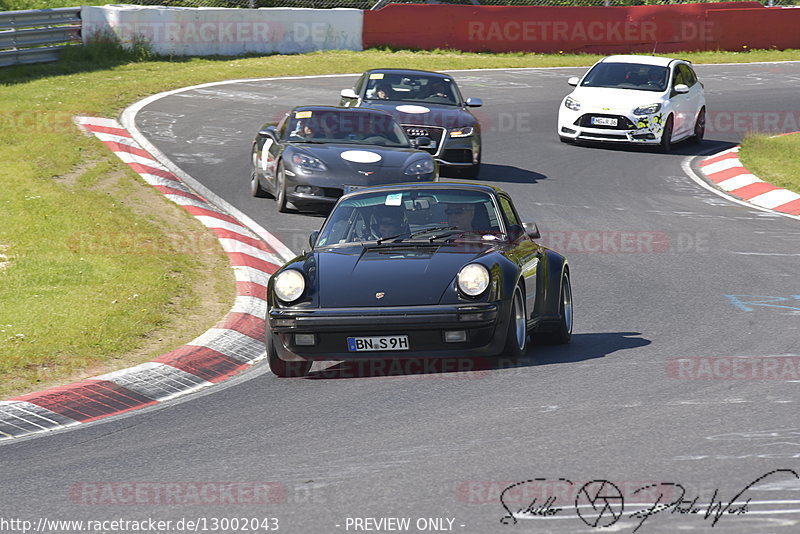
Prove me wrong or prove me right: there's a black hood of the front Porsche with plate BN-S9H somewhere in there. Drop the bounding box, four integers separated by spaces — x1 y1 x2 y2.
317 245 491 308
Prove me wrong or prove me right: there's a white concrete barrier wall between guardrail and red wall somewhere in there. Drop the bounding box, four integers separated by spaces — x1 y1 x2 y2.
81 5 363 56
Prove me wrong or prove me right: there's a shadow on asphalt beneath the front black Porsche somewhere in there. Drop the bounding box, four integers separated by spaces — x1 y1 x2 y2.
306 332 651 380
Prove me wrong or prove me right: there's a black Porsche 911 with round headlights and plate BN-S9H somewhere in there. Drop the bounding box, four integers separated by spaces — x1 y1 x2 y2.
266 183 572 377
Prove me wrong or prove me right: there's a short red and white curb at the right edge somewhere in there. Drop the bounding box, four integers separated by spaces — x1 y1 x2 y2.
700 146 800 215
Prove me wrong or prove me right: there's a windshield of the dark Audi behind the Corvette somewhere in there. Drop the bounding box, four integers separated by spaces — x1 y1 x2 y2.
364 72 459 106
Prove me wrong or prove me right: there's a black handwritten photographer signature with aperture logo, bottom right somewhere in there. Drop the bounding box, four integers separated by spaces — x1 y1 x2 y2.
500 469 800 532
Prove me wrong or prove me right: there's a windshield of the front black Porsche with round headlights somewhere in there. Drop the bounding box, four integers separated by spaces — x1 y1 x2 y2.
316 188 503 247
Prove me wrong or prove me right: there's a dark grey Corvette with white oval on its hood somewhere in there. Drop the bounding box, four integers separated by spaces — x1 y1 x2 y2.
250 106 438 212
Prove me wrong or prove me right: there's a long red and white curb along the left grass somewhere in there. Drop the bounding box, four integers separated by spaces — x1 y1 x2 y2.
0 117 286 440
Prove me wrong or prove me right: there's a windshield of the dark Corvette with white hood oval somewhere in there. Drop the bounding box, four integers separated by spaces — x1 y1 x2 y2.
286 110 411 148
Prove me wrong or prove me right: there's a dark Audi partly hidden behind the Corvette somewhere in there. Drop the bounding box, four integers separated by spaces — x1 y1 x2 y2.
340 69 483 178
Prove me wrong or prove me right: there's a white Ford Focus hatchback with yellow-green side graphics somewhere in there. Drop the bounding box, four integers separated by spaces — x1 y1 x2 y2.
558 55 706 152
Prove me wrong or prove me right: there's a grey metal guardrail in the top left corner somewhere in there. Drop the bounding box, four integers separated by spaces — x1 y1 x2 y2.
0 7 81 67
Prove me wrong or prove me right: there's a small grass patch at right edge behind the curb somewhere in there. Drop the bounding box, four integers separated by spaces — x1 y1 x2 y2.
739 133 800 193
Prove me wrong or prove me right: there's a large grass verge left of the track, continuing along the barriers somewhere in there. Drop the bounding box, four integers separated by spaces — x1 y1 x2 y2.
0 43 800 398
